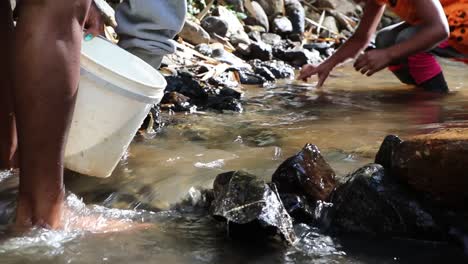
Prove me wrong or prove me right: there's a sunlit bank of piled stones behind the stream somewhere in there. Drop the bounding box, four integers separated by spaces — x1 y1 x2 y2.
155 0 395 112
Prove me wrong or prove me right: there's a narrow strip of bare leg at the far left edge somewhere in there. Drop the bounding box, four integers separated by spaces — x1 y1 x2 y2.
0 0 17 170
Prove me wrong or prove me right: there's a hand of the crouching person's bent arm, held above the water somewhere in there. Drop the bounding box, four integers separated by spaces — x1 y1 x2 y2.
354 49 392 76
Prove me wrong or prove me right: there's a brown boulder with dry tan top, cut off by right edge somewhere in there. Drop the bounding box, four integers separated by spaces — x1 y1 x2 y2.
384 128 468 209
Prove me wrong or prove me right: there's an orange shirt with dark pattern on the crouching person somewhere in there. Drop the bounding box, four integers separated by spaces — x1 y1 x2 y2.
375 0 468 54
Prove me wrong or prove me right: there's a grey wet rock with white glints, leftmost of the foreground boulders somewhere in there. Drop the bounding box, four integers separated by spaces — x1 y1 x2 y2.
212 171 296 243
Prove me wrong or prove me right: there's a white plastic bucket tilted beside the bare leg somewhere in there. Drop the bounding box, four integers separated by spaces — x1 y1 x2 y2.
65 38 166 177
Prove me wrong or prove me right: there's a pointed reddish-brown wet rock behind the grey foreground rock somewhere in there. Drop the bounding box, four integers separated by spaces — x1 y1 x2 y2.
272 144 336 204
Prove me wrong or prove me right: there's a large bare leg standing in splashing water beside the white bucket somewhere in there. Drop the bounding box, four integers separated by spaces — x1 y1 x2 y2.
13 0 91 228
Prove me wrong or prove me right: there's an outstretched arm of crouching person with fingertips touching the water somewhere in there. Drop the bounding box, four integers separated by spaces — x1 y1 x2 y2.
298 1 385 87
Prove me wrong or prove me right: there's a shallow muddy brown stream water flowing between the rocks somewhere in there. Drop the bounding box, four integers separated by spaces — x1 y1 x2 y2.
0 61 468 264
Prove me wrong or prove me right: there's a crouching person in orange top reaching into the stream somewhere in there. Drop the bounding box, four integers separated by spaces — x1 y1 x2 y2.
298 0 468 93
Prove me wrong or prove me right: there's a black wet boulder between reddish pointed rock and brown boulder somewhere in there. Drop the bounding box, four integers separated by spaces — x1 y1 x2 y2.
329 164 444 240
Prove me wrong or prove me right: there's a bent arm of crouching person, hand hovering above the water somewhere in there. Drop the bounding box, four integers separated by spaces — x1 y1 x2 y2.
354 0 450 76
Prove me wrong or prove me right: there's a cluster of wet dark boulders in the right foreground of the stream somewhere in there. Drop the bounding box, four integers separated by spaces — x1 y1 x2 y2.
178 129 468 251
